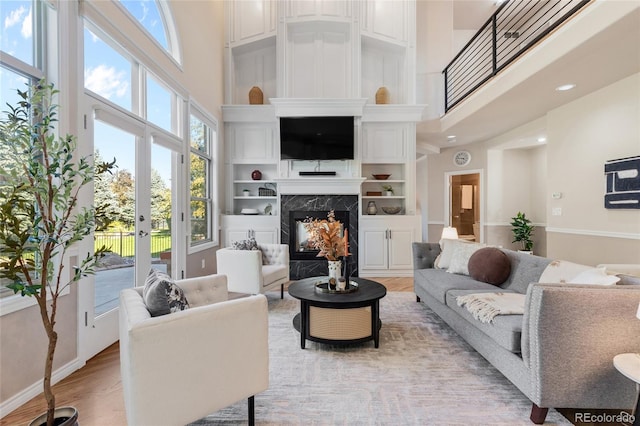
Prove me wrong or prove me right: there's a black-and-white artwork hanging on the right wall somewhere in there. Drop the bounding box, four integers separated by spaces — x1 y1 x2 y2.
604 155 640 209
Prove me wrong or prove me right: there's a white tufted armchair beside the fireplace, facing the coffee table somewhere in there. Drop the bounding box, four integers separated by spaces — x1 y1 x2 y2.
216 244 289 299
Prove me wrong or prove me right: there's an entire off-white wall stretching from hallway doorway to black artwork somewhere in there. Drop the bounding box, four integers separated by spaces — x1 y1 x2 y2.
418 74 640 265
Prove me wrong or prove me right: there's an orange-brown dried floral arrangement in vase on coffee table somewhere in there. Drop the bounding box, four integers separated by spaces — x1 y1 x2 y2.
303 210 349 260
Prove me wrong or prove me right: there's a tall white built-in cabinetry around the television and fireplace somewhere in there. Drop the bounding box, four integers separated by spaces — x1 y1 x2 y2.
222 0 424 253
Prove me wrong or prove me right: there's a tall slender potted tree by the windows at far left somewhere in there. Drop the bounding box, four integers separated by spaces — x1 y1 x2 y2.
0 81 115 426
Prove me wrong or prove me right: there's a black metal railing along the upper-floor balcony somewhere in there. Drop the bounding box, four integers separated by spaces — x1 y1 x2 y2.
443 0 591 112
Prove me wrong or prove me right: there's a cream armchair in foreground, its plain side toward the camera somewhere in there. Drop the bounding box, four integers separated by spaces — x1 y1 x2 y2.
120 275 269 426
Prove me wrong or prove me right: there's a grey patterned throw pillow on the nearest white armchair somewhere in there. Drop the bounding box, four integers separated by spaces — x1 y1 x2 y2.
142 268 189 317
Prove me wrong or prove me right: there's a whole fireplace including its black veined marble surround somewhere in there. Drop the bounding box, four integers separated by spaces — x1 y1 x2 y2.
280 194 358 280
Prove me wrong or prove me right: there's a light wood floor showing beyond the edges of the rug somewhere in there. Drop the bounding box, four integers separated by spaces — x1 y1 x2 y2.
0 277 413 426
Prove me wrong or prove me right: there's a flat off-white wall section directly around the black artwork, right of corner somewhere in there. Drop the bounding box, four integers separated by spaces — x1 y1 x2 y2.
547 74 640 264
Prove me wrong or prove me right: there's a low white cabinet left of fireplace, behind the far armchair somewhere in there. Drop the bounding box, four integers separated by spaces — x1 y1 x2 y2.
221 215 280 247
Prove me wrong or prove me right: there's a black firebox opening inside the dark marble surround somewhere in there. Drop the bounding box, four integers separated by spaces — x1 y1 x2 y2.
289 210 349 261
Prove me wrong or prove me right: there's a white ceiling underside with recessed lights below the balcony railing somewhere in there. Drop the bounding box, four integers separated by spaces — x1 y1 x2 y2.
417 1 640 153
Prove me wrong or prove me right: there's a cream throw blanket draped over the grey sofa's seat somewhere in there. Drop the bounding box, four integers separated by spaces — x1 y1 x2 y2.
456 293 525 323
